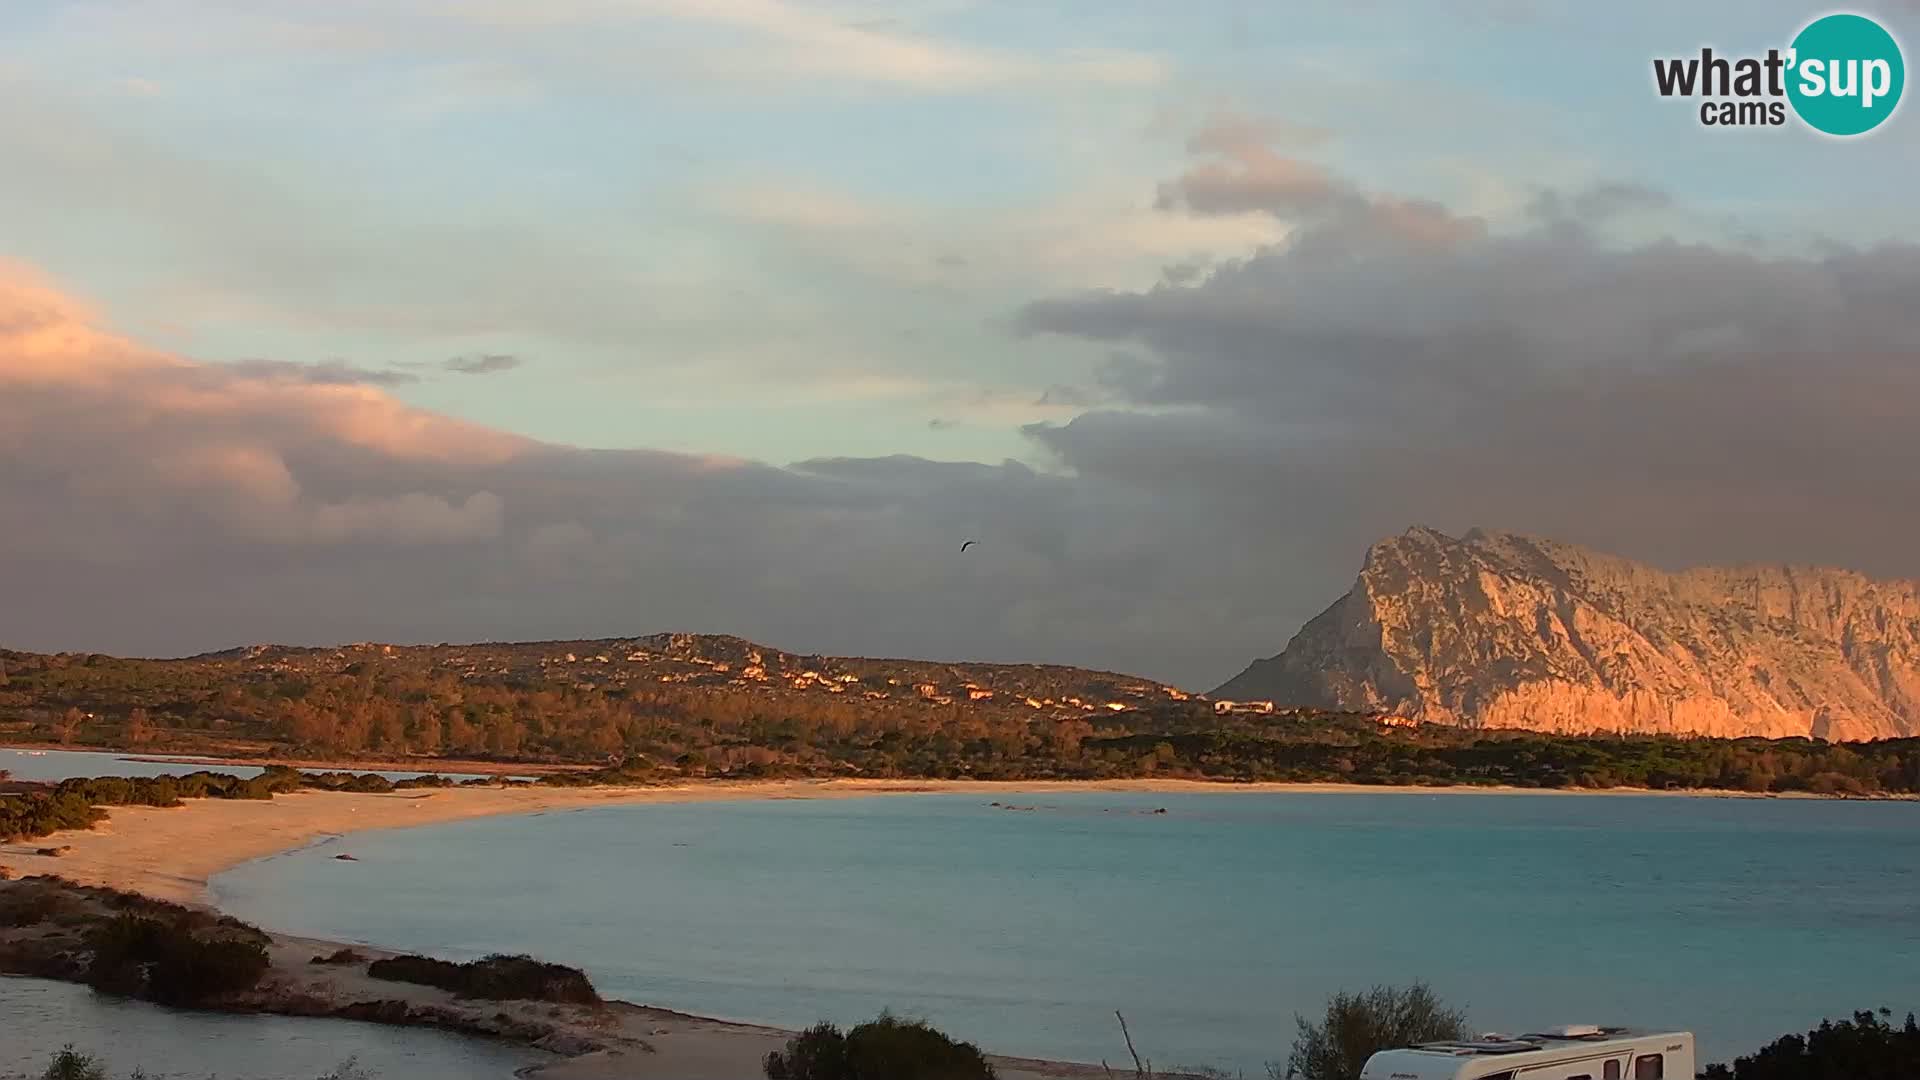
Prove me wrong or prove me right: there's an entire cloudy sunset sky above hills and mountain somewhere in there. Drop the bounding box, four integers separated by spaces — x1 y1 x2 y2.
0 0 1920 688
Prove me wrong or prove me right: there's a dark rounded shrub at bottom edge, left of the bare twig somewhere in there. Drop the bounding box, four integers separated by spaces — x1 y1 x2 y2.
764 1013 995 1080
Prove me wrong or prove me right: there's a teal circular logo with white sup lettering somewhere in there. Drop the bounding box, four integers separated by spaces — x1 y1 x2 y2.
1788 15 1907 135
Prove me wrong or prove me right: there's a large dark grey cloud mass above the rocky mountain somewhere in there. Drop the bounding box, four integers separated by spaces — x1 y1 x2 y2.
1016 150 1920 607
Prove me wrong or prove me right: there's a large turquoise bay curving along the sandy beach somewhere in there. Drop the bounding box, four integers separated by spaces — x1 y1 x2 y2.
215 794 1920 1074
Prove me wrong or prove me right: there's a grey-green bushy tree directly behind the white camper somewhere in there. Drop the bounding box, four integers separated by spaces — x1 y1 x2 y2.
1267 982 1467 1080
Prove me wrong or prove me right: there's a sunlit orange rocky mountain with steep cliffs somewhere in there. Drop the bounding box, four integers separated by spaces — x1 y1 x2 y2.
1213 528 1920 740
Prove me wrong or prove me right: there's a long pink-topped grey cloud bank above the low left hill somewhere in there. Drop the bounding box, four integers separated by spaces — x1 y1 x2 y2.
0 259 1283 680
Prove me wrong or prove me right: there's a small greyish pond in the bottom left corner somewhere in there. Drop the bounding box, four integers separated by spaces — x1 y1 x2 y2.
0 976 553 1080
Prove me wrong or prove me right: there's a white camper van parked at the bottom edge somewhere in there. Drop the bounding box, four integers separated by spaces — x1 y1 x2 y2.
1359 1024 1693 1080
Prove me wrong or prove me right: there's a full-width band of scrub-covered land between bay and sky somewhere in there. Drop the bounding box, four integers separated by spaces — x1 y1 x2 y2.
0 634 1920 794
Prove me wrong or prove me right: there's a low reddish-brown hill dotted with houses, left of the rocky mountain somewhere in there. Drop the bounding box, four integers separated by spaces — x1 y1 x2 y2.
0 634 1206 767
